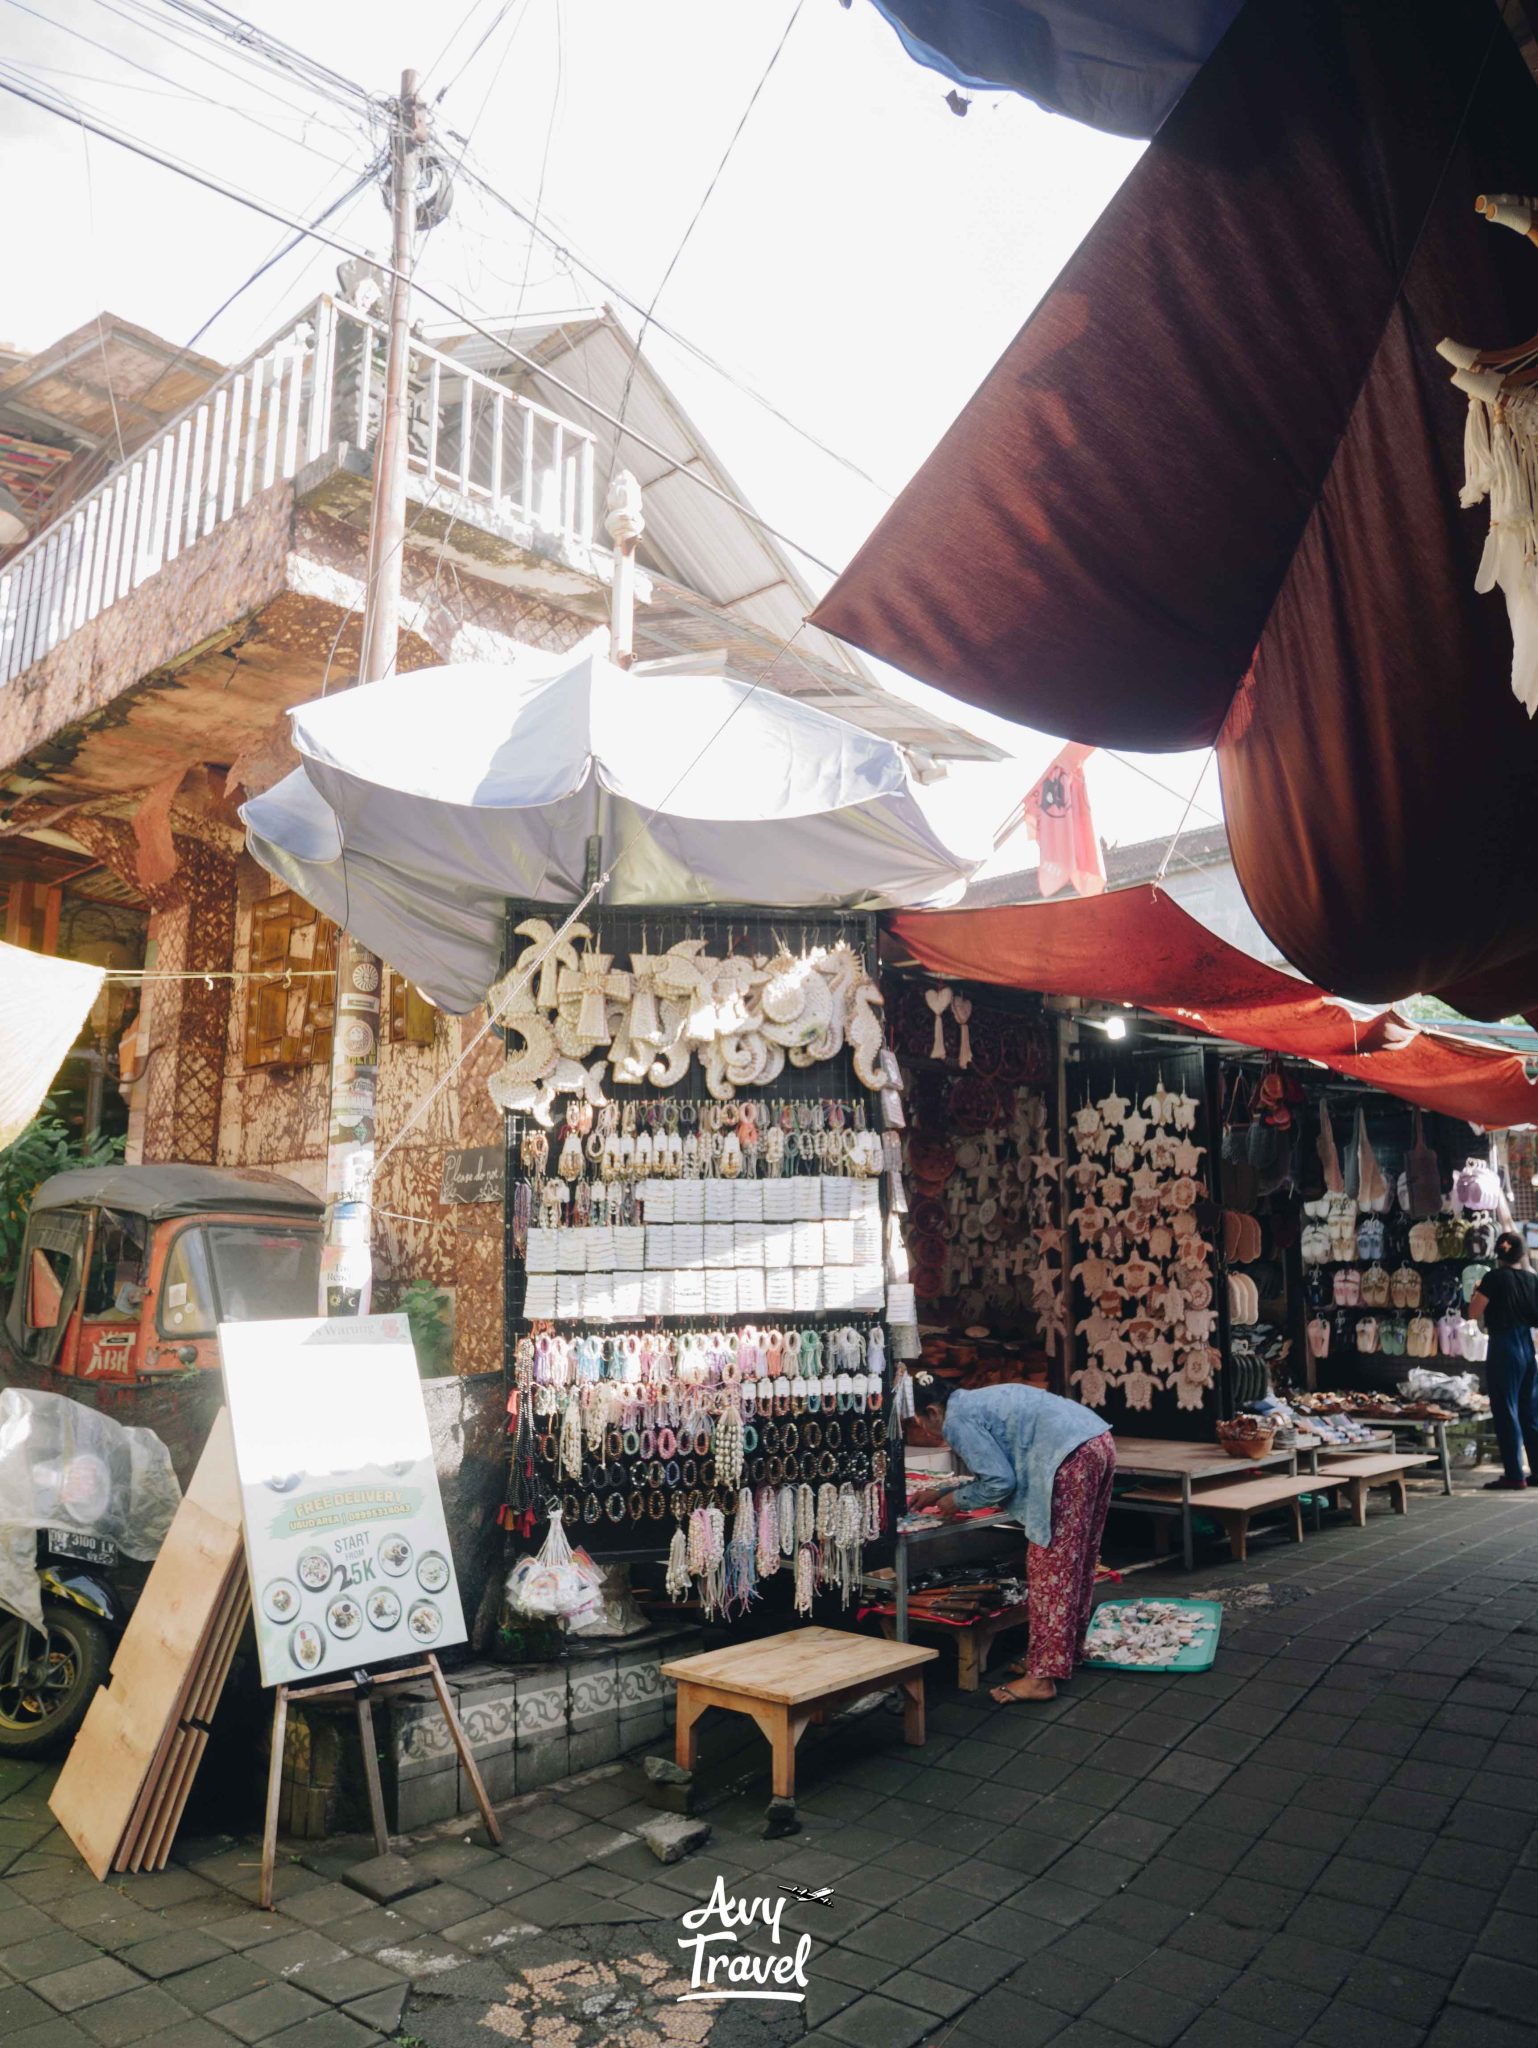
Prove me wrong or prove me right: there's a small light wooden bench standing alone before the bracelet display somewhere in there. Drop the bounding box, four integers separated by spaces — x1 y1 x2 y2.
661 1628 940 1798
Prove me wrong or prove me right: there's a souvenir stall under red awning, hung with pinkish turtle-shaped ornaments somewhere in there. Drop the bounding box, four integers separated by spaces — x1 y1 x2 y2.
872 891 1538 1593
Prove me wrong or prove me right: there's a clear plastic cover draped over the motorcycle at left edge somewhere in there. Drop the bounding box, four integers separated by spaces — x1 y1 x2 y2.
0 1386 182 1628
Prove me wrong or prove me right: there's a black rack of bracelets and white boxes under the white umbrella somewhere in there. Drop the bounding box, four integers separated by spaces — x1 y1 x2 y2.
494 905 903 1616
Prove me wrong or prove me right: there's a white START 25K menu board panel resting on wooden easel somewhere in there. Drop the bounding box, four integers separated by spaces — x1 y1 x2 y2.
219 1315 465 1686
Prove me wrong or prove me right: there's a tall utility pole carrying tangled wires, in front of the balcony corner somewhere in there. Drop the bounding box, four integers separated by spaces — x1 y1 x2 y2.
319 72 426 1315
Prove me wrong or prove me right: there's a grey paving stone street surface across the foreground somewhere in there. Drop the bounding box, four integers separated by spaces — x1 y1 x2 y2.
0 1493 1538 2048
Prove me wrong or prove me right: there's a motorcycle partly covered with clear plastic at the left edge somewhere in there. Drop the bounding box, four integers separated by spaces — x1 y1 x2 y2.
0 1386 180 1757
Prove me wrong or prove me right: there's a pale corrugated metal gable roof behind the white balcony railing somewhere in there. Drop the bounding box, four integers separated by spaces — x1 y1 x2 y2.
430 307 1003 762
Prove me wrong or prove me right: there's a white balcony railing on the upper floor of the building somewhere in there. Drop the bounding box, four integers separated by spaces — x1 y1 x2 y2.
0 299 594 684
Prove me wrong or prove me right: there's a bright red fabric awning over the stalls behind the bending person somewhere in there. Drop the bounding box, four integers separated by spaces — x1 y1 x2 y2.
889 885 1538 1128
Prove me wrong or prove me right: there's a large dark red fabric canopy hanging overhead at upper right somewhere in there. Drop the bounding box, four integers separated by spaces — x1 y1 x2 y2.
815 0 1538 1016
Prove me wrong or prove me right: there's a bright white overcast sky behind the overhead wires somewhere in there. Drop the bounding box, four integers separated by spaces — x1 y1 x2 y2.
0 0 1221 866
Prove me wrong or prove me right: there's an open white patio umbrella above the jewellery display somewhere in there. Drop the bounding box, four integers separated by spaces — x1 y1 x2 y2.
242 647 987 1014
